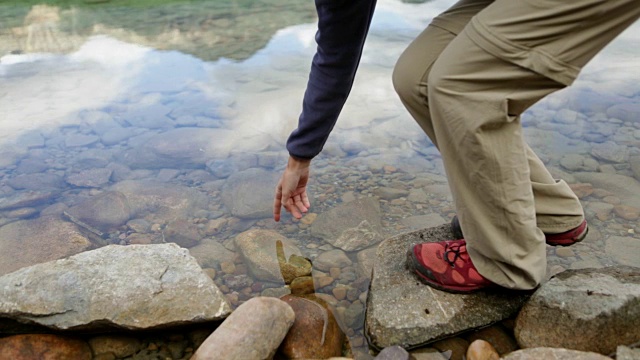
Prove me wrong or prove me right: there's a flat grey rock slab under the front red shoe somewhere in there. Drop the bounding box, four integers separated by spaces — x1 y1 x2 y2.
365 224 531 349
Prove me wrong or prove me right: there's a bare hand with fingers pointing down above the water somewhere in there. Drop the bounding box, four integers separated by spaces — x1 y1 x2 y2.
273 156 311 221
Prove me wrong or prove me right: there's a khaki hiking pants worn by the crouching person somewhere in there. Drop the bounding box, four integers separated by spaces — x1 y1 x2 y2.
393 0 640 289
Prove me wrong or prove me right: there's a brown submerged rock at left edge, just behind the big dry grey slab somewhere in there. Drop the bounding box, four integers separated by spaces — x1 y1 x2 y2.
0 216 93 275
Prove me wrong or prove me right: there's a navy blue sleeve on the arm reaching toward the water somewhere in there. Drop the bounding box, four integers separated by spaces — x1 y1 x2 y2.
287 0 376 159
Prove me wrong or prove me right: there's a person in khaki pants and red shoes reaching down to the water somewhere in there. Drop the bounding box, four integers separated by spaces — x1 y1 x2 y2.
273 0 640 293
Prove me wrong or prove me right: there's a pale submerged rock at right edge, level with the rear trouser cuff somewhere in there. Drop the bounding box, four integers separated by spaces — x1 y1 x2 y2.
575 172 640 206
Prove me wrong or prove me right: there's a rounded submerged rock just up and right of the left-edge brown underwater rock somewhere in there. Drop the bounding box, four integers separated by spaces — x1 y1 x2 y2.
67 191 132 231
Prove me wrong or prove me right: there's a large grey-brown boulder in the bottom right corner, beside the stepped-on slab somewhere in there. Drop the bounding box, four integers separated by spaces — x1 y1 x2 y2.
515 266 640 354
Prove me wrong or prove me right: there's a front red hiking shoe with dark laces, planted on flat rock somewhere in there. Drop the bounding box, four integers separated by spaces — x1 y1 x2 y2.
407 239 497 293
